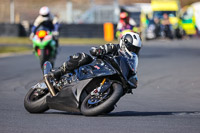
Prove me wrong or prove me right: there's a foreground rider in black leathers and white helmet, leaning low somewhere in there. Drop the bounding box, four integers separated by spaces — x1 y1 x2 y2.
50 32 142 92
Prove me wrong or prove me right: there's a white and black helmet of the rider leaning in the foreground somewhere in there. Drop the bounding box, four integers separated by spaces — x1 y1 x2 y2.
119 32 142 54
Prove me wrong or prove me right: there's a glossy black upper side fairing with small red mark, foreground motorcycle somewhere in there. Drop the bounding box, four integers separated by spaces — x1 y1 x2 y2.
77 59 117 80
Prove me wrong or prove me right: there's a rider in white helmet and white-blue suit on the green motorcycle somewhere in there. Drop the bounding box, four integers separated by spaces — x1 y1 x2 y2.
30 6 60 47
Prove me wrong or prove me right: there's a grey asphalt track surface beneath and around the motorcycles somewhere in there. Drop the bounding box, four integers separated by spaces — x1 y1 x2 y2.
0 40 200 133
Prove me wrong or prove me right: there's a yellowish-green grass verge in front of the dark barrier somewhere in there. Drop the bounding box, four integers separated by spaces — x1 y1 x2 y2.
0 37 117 54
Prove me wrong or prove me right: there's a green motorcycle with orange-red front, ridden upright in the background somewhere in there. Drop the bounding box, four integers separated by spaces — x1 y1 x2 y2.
32 26 57 68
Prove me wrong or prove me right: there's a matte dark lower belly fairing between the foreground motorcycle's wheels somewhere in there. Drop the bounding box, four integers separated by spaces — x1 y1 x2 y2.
46 79 92 112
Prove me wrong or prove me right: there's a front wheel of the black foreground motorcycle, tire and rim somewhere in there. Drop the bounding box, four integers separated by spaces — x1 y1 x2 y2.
81 83 123 116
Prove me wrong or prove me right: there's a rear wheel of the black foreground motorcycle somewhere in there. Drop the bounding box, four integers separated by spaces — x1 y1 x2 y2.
24 88 50 113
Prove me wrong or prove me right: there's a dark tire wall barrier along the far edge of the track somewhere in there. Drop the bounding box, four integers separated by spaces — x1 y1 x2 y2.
0 23 116 38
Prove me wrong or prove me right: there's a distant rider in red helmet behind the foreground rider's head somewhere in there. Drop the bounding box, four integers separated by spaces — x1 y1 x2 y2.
116 12 136 37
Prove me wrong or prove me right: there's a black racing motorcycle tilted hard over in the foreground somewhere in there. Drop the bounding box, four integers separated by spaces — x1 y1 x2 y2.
24 55 136 116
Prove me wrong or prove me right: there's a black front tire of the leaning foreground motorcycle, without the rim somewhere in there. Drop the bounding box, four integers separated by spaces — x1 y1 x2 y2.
81 83 123 116
